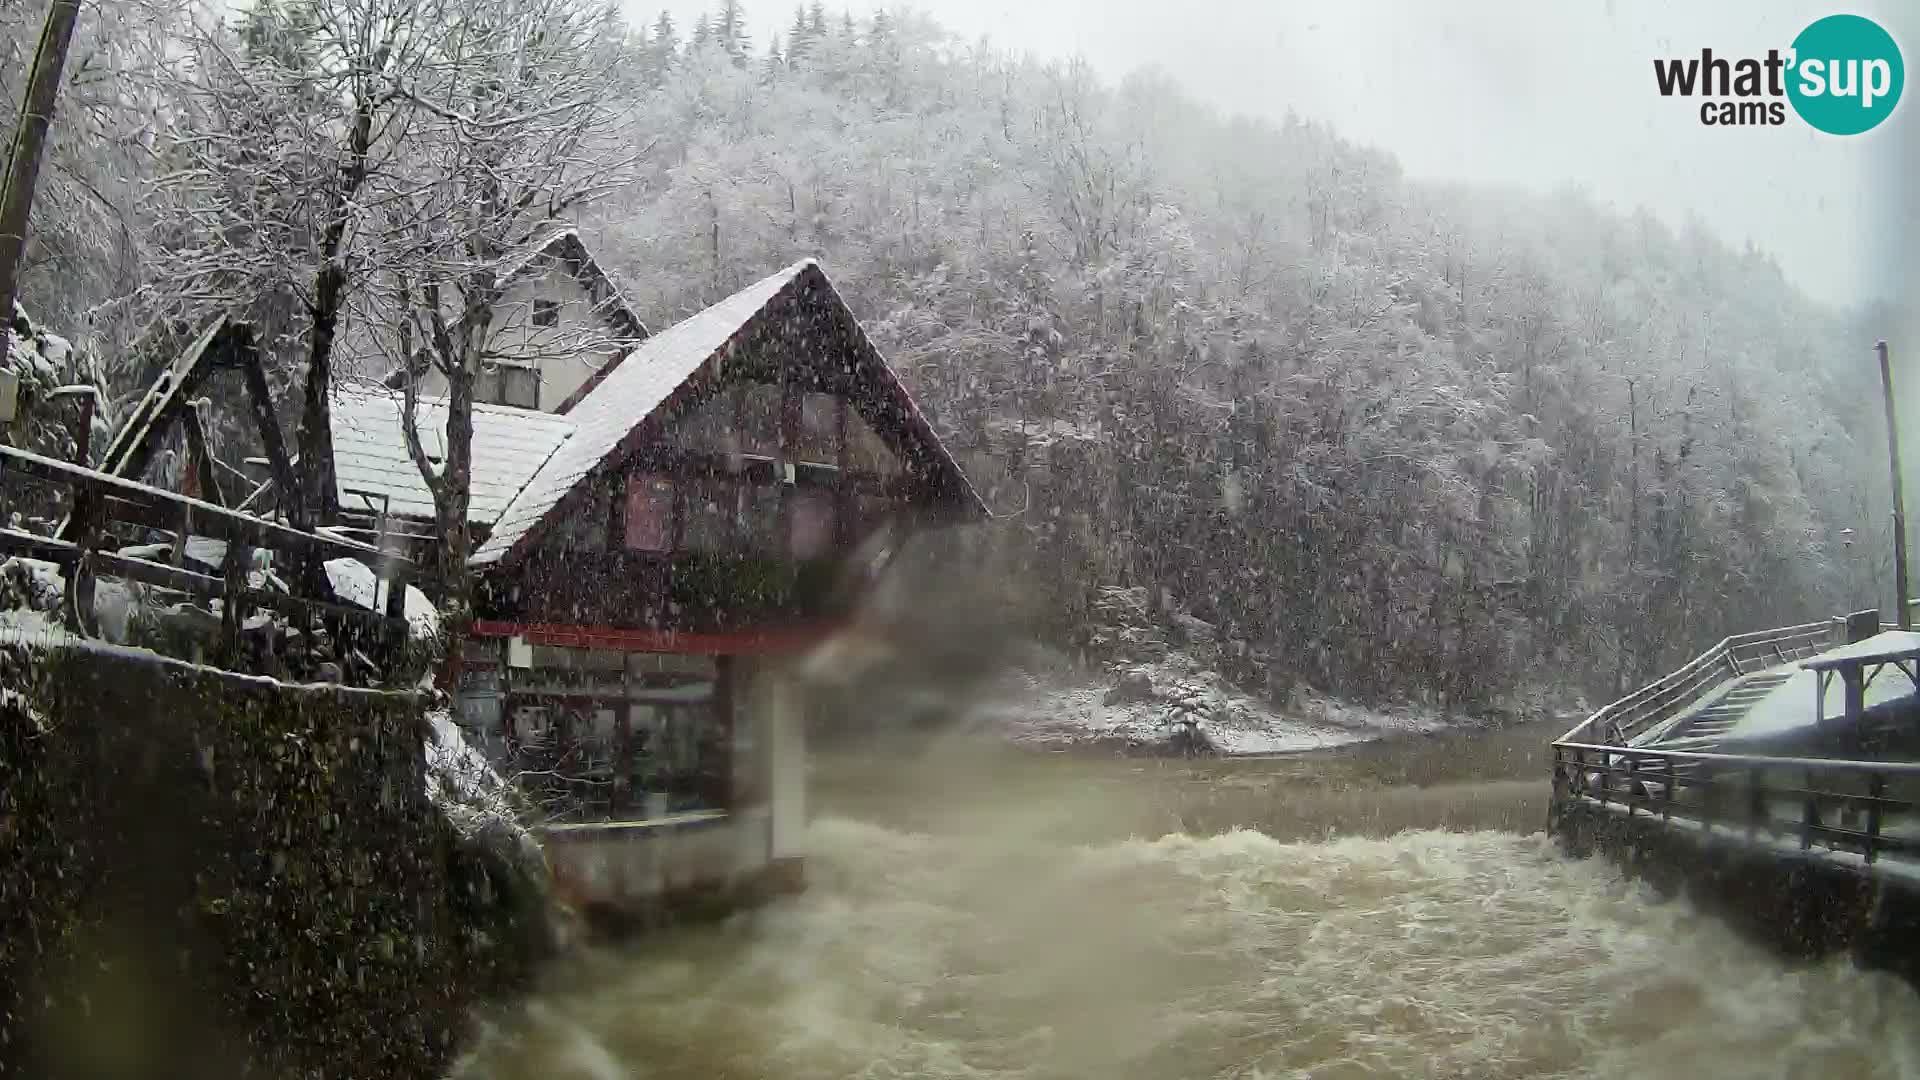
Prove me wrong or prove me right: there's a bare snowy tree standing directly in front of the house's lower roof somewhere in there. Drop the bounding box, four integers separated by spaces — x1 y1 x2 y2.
369 0 643 648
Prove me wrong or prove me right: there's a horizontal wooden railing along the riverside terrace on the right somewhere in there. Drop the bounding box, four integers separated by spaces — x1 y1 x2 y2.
1553 740 1920 865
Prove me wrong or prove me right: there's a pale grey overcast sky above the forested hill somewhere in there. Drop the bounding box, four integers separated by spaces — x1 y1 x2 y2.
648 0 1920 304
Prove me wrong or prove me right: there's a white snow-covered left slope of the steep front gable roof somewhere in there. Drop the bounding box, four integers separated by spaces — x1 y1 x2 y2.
472 259 814 565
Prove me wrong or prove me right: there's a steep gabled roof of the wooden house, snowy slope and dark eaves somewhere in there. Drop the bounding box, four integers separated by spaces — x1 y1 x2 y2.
472 259 987 565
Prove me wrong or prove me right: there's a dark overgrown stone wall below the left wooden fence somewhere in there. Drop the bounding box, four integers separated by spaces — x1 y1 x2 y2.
0 644 480 1078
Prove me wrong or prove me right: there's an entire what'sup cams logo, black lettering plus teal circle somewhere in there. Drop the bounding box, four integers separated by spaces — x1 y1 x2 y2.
1653 15 1907 135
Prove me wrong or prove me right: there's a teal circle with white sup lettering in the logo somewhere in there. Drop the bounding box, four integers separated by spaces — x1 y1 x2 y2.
1788 15 1907 135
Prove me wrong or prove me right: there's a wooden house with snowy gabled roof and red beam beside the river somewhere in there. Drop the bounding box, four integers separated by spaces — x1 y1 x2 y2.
334 249 985 909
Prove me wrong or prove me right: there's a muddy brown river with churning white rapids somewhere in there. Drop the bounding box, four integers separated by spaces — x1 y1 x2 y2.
455 728 1920 1080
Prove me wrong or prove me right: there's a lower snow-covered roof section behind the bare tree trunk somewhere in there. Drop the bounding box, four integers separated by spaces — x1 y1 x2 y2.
332 384 574 525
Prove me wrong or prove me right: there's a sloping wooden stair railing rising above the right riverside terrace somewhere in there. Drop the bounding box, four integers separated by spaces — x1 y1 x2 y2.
1561 621 1845 746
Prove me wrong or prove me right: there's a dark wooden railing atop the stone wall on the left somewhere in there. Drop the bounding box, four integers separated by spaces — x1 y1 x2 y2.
0 446 413 680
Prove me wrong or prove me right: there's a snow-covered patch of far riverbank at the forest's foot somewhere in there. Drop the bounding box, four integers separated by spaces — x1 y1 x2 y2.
975 653 1448 755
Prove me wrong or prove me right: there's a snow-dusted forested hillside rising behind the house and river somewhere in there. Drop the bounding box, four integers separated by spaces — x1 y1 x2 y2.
6 4 1891 707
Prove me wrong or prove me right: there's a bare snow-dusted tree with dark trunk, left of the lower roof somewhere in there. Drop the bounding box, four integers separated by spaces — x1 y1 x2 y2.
148 0 442 527
